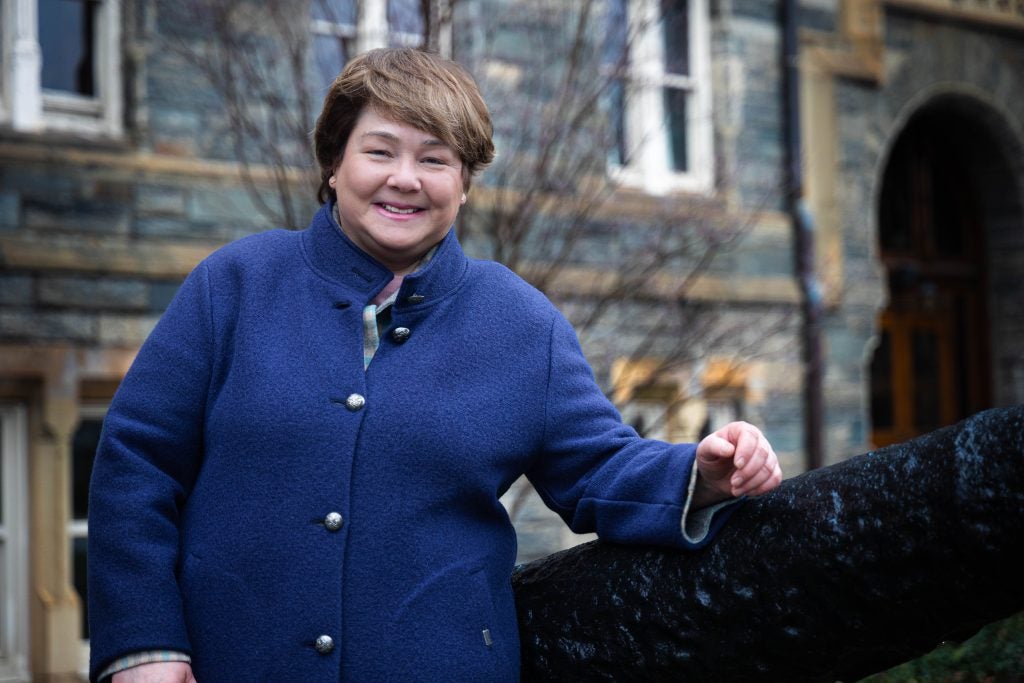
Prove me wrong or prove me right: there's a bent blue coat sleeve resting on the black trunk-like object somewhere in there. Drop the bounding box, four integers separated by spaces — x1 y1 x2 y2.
527 314 734 548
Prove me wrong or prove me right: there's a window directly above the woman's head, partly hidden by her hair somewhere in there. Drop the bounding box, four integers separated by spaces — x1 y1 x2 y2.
311 0 427 87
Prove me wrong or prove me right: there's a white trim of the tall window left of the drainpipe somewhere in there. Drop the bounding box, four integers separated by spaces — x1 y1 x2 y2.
610 0 715 195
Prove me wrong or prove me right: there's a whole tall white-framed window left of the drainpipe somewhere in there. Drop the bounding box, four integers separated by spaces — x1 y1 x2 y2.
603 0 714 195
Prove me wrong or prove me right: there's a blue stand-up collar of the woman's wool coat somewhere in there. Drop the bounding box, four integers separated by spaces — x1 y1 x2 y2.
302 202 469 308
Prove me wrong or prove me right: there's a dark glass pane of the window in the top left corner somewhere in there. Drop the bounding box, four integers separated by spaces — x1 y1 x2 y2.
39 0 99 97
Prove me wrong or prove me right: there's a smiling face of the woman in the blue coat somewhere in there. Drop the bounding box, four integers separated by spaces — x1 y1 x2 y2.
330 109 466 274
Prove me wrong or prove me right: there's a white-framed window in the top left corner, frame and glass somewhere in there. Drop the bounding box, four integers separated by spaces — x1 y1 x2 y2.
0 0 123 136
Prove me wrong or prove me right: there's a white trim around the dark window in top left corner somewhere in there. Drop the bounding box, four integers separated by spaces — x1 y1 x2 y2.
0 0 124 137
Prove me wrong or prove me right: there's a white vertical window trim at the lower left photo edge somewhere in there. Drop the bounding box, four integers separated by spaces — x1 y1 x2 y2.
0 405 31 683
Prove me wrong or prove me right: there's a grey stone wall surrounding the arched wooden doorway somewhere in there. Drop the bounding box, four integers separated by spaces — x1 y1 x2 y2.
828 6 1024 454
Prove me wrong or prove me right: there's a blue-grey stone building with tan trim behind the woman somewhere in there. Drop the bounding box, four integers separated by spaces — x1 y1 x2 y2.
0 0 1024 681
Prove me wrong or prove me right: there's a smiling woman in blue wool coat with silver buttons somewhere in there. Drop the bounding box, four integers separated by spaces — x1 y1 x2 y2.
89 49 780 683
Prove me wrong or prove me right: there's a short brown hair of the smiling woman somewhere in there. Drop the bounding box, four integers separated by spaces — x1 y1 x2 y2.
313 47 495 204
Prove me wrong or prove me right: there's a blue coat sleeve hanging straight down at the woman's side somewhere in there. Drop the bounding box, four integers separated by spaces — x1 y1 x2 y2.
88 264 213 680
